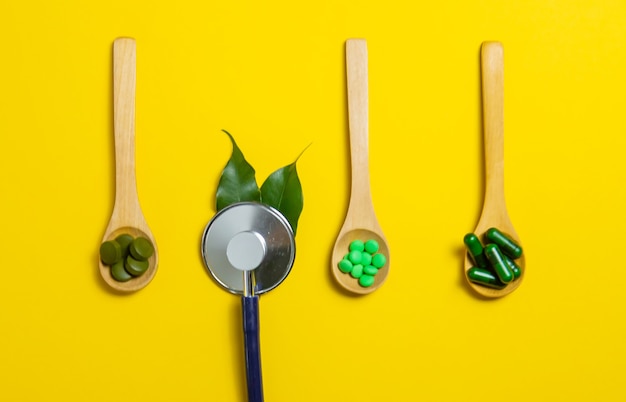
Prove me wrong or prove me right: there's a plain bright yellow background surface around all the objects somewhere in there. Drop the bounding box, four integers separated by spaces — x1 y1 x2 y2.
0 0 626 402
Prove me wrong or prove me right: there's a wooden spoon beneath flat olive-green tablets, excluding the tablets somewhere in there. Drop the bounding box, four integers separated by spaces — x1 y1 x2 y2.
98 38 159 292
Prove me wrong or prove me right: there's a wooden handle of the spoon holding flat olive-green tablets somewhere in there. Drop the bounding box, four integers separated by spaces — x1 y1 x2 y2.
113 38 141 221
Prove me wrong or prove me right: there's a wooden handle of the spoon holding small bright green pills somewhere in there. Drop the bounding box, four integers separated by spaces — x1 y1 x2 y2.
346 39 373 216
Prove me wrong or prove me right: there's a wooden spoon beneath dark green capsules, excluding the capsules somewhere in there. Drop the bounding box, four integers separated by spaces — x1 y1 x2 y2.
464 42 526 298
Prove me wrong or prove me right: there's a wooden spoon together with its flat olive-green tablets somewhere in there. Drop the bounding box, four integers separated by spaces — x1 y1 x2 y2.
99 38 159 292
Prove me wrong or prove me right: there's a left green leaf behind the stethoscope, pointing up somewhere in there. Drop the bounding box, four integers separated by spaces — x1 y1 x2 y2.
215 130 261 211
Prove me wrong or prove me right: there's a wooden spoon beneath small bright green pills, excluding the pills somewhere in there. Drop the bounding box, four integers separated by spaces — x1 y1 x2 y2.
331 39 390 294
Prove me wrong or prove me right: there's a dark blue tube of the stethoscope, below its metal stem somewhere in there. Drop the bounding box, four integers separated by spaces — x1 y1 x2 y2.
241 296 263 402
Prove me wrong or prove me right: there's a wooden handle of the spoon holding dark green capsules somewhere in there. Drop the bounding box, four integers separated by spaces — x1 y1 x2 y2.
481 42 505 211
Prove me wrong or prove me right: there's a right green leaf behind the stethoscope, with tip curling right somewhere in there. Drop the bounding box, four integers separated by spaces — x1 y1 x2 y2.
261 147 308 235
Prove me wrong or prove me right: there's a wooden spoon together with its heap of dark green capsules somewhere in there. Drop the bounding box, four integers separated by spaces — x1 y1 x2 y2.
464 42 526 298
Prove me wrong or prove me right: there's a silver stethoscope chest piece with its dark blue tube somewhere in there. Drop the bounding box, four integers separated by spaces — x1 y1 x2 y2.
202 202 296 402
